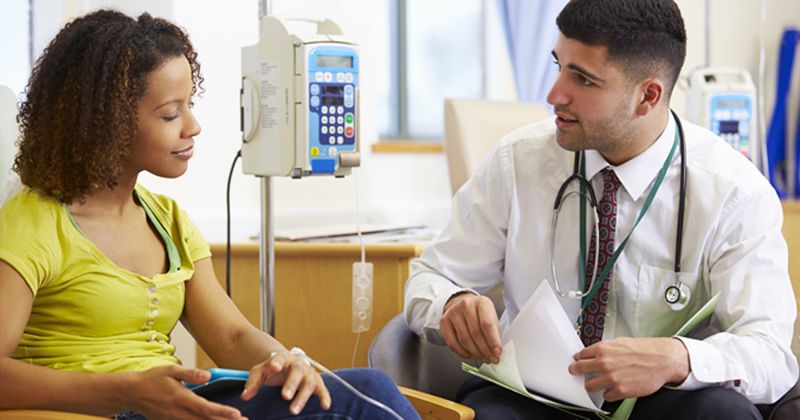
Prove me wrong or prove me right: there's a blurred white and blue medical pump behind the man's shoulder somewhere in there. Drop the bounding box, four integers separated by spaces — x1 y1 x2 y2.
686 67 758 160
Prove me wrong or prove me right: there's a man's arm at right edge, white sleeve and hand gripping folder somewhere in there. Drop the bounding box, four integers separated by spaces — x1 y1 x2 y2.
570 185 798 404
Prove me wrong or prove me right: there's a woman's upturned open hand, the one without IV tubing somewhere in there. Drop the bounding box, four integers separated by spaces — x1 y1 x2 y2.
126 365 244 420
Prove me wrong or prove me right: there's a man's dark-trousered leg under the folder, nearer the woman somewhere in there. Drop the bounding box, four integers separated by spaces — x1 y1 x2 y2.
456 378 575 420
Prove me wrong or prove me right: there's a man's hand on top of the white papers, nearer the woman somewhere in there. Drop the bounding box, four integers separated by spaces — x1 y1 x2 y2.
439 292 503 363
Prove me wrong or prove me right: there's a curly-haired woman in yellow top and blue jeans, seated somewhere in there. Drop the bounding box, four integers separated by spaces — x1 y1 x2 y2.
0 11 417 419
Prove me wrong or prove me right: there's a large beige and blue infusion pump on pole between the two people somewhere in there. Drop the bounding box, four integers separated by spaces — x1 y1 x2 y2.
241 16 360 178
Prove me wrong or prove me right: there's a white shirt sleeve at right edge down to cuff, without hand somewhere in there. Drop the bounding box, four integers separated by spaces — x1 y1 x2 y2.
677 183 798 404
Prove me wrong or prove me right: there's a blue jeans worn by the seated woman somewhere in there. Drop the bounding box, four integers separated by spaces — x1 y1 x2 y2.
115 369 420 420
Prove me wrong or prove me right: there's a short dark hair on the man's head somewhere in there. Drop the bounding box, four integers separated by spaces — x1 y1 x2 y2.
556 0 686 98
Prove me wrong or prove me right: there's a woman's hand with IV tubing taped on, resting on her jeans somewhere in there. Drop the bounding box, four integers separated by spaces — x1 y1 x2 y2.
242 350 331 414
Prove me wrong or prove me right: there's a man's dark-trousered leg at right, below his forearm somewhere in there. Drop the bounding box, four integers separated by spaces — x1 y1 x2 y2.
616 387 761 420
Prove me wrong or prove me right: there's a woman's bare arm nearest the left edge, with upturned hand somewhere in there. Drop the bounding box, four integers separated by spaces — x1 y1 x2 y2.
0 260 240 419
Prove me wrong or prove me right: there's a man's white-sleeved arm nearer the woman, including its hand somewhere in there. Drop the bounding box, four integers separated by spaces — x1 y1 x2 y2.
405 143 513 358
